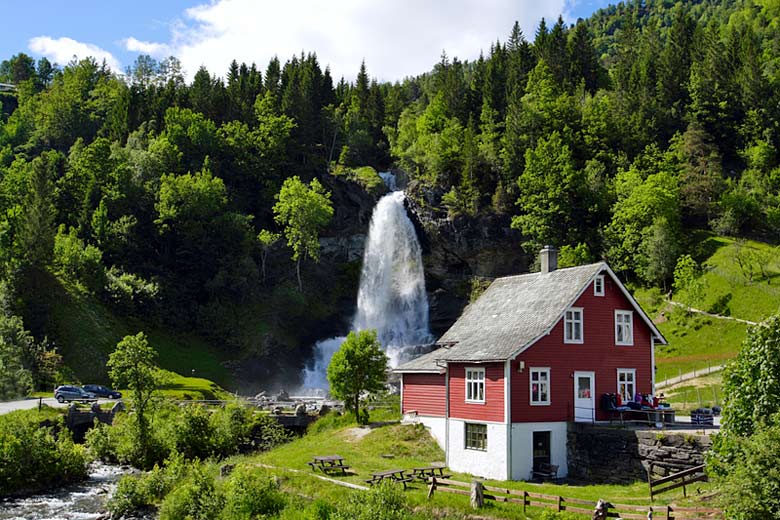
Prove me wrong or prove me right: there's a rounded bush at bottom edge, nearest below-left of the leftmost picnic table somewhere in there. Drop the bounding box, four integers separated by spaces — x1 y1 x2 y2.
220 467 287 520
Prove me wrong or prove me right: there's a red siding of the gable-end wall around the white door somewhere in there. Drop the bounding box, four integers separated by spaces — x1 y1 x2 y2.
511 275 652 422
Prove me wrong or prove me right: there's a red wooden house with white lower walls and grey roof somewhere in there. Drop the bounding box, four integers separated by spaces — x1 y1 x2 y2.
396 246 666 480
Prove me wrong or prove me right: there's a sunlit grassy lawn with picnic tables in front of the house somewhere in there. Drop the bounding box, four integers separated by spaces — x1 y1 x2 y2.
247 412 710 518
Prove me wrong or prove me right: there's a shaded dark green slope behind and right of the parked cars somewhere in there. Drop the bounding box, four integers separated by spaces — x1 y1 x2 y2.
44 276 231 387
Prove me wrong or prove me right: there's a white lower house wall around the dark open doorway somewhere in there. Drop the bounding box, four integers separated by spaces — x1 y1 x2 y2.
512 422 568 480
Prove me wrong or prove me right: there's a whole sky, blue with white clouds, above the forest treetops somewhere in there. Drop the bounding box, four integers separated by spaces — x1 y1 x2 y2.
0 0 609 80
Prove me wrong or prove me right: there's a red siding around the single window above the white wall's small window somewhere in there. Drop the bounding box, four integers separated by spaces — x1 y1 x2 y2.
449 363 504 422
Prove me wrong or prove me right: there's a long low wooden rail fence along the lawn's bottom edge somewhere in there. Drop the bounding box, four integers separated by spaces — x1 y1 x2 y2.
428 477 723 520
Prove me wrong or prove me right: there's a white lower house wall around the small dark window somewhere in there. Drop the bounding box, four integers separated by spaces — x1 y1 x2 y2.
446 419 507 480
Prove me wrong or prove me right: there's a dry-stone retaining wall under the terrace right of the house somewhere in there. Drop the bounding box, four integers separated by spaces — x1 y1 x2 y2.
568 423 710 484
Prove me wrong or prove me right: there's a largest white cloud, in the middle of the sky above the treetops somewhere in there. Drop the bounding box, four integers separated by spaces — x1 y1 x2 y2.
134 0 572 81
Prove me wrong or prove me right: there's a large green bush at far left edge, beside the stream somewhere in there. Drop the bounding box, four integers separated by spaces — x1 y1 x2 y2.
0 411 88 496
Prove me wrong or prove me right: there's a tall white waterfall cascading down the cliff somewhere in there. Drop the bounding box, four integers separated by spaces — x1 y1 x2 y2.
303 175 432 390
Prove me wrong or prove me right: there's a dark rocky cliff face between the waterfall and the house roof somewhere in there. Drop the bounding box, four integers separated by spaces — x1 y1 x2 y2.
406 182 528 337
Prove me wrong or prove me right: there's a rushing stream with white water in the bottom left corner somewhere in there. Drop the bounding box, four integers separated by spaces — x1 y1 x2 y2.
0 463 143 520
